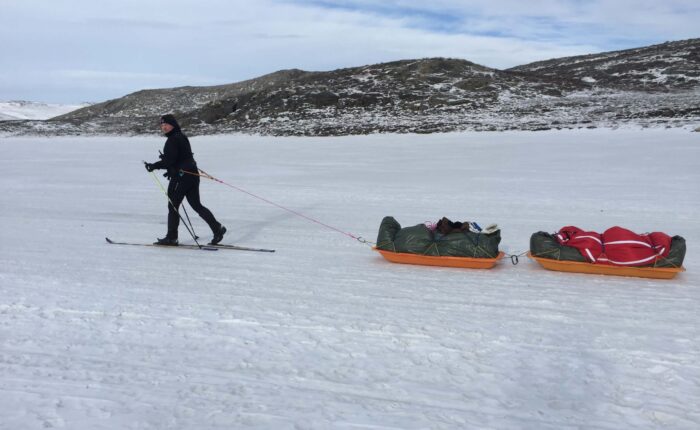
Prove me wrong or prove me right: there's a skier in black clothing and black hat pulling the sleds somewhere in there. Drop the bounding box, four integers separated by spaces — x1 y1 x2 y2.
146 114 226 245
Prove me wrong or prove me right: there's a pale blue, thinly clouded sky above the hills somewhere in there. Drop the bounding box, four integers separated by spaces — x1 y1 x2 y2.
0 0 700 103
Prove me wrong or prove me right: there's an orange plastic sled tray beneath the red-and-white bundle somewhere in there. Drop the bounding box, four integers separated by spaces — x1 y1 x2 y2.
527 252 685 279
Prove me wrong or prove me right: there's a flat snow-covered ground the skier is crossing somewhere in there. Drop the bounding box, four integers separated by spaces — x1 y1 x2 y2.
0 129 700 430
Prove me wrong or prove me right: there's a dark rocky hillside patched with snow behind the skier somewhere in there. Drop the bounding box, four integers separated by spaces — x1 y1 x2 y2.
0 39 700 135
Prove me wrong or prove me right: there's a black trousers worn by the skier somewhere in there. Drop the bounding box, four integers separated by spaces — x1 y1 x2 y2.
167 175 221 239
